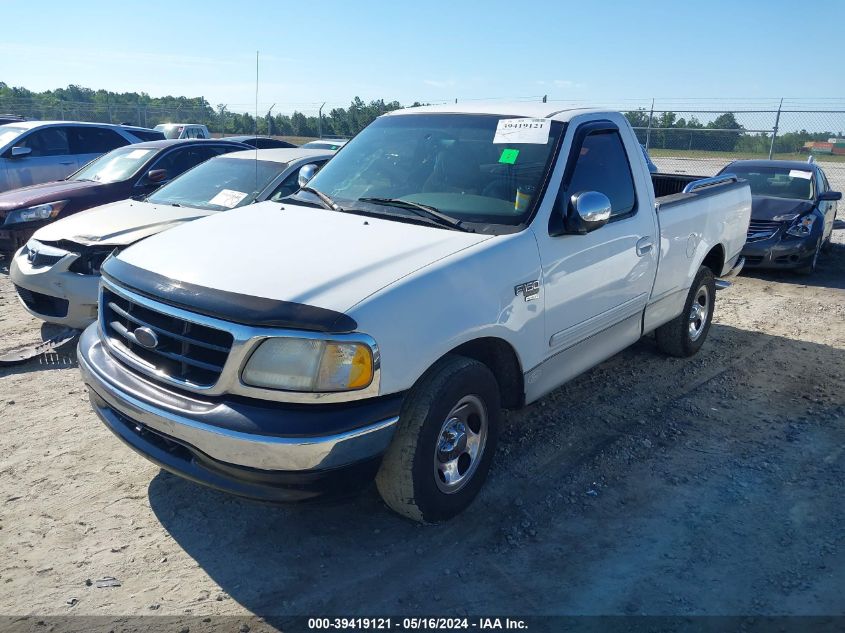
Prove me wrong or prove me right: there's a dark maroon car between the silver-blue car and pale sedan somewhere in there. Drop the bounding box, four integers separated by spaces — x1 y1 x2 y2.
0 139 249 258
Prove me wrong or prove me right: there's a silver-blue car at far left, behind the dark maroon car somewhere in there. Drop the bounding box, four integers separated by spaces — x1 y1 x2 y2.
0 121 162 192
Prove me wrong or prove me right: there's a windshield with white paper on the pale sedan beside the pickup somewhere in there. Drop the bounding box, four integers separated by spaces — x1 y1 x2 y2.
147 157 287 211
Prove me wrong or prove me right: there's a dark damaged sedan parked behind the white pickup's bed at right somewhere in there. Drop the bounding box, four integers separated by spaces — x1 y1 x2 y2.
719 160 842 274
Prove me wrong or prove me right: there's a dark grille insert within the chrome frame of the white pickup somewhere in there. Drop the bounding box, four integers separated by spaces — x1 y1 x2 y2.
100 287 233 387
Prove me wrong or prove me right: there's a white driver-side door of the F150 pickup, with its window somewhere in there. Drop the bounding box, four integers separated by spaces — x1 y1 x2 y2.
536 116 657 384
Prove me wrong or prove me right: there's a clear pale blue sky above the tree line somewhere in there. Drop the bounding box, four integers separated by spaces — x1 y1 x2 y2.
0 0 845 112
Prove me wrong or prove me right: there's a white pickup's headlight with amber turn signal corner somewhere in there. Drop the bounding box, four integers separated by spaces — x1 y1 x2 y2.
241 338 374 392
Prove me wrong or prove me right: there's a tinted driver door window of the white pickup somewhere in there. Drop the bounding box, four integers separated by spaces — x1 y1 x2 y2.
567 130 637 219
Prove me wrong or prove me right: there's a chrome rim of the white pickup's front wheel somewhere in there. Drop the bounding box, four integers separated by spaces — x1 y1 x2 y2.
434 396 487 494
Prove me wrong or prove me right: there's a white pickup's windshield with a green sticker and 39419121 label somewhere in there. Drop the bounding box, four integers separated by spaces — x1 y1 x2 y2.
299 114 563 229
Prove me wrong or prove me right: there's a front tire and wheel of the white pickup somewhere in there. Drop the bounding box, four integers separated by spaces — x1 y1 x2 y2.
376 356 502 523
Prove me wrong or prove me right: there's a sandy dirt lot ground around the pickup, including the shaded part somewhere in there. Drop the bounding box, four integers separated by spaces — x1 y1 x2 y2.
0 228 845 630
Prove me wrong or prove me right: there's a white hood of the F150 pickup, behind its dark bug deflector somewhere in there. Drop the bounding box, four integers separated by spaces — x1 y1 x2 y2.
118 202 491 312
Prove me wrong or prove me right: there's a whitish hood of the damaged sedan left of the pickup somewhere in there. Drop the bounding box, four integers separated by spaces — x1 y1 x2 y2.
34 200 215 246
